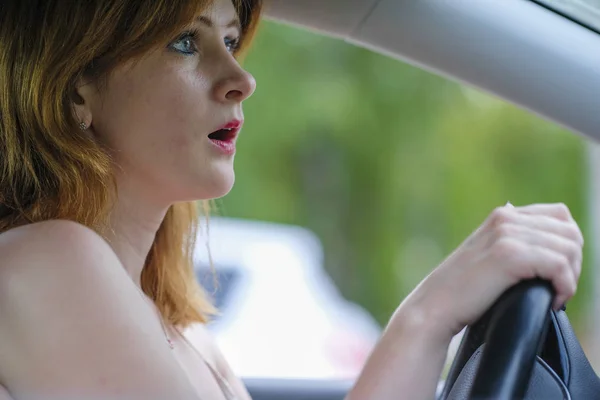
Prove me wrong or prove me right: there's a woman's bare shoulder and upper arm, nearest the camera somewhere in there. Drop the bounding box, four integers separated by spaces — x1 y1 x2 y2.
0 221 203 400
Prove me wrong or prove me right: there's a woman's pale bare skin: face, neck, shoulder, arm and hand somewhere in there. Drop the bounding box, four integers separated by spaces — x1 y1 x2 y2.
0 0 583 400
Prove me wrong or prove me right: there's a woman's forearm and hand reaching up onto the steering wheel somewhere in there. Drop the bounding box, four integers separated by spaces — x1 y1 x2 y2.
347 204 583 400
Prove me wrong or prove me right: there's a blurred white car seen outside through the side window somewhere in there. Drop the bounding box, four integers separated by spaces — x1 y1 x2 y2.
189 218 381 380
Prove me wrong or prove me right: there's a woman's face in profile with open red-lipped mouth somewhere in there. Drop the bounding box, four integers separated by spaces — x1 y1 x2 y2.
78 0 256 203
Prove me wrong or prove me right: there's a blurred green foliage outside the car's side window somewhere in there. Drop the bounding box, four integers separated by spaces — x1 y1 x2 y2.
221 23 590 332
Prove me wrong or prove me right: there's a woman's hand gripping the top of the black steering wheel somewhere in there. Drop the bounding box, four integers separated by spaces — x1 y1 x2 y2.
398 204 583 340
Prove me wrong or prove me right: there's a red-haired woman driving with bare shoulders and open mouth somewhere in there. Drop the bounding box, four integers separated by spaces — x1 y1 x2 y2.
0 0 583 400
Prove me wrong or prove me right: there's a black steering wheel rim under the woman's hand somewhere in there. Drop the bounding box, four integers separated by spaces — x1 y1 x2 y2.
441 279 554 400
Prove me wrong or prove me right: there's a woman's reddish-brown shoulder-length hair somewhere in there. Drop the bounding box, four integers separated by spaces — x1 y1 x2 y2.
0 0 261 327
